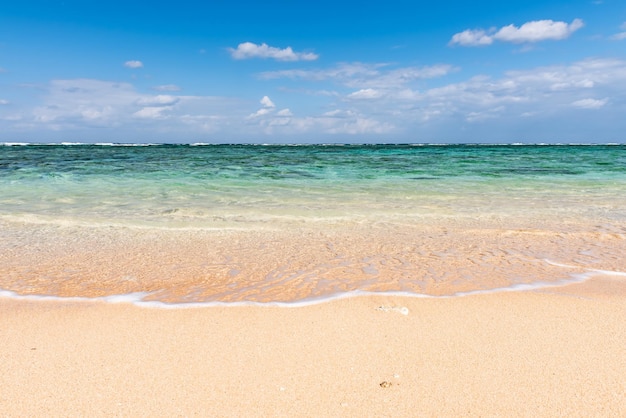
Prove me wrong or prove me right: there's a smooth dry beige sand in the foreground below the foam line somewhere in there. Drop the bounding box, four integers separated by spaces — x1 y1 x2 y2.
0 277 626 417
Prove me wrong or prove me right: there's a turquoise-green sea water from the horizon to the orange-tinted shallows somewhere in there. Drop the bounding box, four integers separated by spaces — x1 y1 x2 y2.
0 145 626 227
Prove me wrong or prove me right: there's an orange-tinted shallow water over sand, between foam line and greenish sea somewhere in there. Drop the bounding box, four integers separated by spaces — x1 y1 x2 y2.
0 217 626 303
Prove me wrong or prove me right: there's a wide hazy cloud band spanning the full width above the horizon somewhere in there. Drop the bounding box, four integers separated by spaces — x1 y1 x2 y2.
0 59 626 141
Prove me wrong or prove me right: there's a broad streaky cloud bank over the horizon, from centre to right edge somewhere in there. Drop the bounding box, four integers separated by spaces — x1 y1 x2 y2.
251 59 626 140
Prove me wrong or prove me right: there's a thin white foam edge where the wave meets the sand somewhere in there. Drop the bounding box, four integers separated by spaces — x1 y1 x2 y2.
0 263 626 309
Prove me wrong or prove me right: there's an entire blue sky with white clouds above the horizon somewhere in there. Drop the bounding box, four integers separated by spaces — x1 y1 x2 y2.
0 0 626 143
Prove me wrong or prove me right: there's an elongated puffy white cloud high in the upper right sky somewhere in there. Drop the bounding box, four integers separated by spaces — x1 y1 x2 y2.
449 19 584 46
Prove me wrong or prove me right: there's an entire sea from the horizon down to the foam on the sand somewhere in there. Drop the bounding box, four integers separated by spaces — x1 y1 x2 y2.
0 143 626 304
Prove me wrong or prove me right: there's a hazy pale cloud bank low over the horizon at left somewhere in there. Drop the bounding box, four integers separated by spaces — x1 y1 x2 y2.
9 79 245 139
